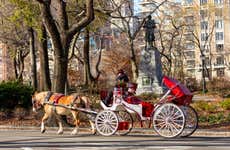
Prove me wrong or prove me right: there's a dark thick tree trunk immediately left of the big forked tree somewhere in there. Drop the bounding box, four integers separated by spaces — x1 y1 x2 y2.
38 25 51 91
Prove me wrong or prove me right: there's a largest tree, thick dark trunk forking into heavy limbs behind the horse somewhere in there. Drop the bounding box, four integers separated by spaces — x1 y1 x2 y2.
37 0 94 92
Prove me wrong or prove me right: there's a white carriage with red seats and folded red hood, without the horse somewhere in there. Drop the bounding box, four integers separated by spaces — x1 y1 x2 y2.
95 76 198 137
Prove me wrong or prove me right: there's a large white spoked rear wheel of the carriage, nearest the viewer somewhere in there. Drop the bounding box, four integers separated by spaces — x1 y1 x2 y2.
153 103 185 138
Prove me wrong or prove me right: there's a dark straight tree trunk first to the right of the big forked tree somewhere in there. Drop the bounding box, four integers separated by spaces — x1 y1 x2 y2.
83 29 94 85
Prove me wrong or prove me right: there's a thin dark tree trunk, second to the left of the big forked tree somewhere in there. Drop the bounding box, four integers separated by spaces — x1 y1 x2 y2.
29 28 38 90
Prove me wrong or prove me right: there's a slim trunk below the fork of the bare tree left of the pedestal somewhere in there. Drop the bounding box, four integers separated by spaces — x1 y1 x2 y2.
130 40 138 82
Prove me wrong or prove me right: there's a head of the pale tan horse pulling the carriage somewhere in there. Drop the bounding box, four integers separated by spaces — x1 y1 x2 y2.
32 92 47 112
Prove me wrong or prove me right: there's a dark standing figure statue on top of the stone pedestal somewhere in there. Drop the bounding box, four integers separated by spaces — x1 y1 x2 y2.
143 15 156 47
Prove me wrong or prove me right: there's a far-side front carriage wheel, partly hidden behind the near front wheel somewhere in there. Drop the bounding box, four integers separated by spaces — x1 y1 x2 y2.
116 111 133 135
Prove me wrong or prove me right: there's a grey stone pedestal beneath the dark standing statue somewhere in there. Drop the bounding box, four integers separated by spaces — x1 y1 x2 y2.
136 47 163 95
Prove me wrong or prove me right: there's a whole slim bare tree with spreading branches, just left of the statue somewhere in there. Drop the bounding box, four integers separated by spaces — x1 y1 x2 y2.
97 0 167 81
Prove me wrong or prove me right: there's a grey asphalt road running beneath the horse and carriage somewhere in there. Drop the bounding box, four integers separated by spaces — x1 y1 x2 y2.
0 130 230 150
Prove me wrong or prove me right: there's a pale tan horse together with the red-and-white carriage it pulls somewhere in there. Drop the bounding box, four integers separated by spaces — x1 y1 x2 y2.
32 76 198 138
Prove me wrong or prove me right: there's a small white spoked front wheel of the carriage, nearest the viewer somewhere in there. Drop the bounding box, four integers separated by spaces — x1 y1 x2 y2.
95 110 118 136
